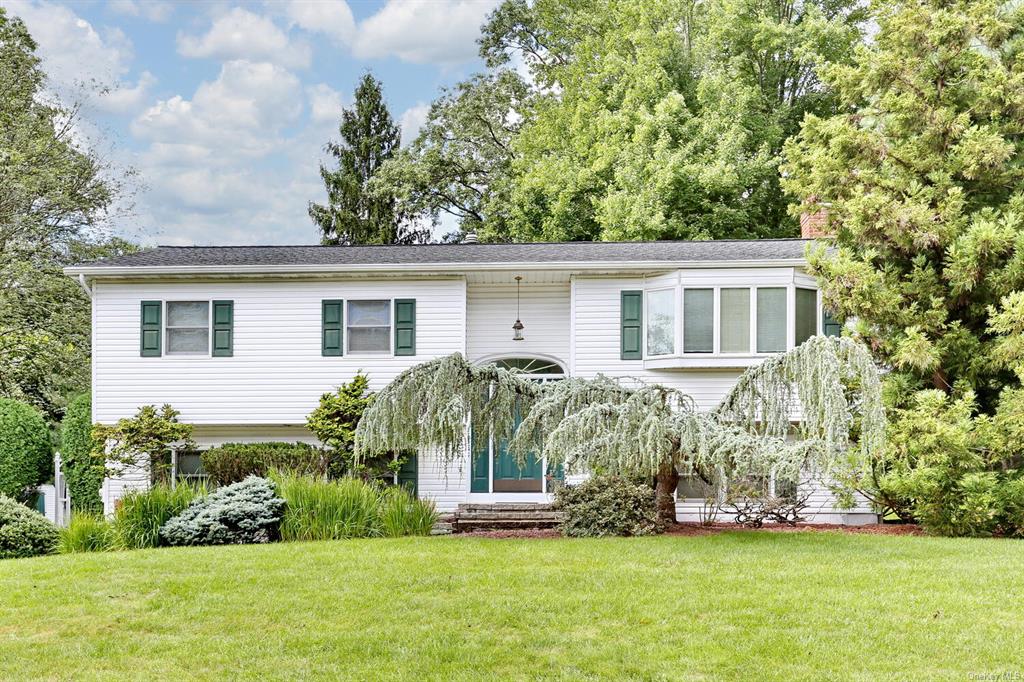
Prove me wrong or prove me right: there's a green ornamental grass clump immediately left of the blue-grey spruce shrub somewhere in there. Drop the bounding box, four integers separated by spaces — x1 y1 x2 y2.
114 483 206 549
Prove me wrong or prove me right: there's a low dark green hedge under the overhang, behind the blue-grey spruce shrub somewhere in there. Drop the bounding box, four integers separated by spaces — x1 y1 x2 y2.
201 442 344 485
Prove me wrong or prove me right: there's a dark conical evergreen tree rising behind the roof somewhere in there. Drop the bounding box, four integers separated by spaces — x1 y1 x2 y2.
309 74 424 245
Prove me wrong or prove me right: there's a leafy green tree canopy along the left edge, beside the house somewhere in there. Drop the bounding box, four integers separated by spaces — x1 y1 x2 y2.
0 8 135 422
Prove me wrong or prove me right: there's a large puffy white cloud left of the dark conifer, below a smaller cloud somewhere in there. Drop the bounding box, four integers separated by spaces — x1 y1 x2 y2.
131 60 302 156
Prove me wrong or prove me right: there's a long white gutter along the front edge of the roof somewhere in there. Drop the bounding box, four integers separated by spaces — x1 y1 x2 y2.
63 258 807 278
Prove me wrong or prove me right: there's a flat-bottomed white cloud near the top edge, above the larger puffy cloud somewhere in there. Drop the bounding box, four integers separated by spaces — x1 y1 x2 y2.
178 7 311 67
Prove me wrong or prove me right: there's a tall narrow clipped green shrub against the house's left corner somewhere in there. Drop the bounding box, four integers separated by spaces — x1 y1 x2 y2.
60 393 104 514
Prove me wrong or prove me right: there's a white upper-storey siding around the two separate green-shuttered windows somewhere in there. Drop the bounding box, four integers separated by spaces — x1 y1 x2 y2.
92 278 468 425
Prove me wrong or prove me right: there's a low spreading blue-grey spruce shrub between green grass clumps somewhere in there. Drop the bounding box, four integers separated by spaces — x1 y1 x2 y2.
160 476 285 545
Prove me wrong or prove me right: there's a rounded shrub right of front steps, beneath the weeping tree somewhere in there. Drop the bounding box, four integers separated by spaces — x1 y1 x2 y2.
555 476 663 538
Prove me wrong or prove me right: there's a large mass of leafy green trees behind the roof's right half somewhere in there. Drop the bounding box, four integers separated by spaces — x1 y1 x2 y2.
384 0 864 241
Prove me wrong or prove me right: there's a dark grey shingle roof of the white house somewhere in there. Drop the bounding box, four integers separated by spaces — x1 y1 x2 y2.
82 239 808 268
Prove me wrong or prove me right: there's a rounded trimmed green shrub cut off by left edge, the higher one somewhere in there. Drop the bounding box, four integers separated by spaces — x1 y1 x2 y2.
0 398 53 500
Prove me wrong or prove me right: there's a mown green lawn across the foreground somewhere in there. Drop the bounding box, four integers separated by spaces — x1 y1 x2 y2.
0 532 1024 680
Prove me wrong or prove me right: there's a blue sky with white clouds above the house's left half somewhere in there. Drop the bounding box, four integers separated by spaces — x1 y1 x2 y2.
0 0 497 244
